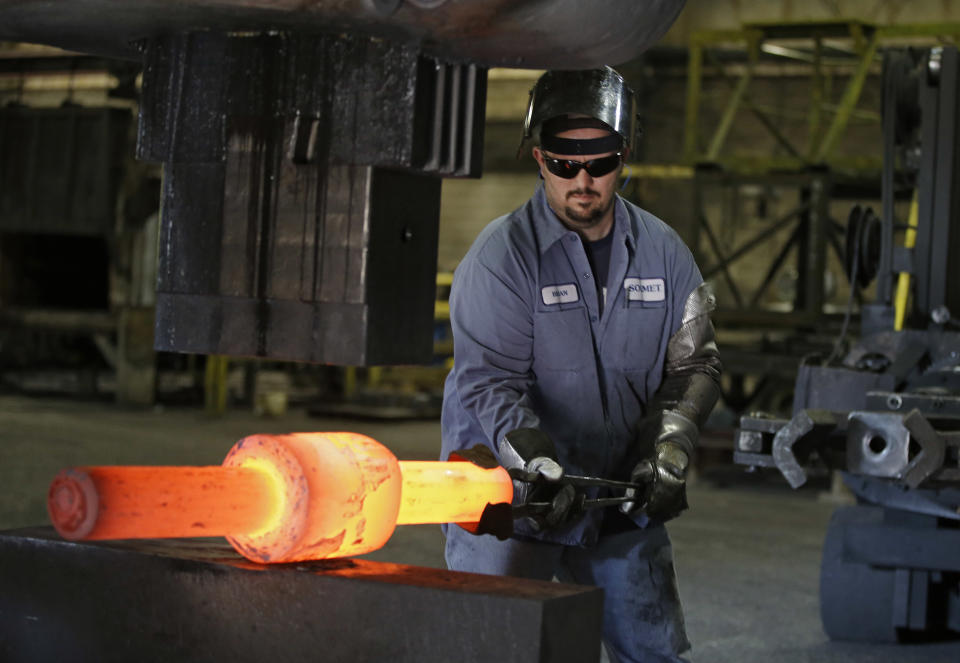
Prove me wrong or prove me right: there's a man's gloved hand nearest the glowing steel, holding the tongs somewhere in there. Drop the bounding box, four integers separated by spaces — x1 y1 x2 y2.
498 428 576 530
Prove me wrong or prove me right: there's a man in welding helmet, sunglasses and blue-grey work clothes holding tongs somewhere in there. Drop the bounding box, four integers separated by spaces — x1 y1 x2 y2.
442 67 720 662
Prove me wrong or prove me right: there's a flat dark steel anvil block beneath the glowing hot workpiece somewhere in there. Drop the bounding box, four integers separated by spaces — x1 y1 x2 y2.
0 528 602 663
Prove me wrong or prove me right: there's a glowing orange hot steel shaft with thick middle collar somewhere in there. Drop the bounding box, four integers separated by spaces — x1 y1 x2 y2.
47 433 513 563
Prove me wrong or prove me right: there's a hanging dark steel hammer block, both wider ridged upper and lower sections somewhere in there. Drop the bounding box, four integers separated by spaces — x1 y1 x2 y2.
137 33 468 365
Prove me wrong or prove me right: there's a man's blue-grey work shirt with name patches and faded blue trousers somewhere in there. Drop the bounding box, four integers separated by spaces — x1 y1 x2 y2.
441 185 703 661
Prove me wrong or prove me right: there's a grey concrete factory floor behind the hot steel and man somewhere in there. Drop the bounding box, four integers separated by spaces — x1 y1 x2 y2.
0 396 960 663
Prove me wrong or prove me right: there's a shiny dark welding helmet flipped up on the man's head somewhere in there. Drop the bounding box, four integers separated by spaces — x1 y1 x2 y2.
520 67 640 154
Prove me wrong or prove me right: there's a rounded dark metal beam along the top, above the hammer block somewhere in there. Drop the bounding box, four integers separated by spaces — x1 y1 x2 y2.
0 0 684 68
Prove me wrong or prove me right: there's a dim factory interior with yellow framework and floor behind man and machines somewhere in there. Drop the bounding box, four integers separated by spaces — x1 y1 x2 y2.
0 0 960 663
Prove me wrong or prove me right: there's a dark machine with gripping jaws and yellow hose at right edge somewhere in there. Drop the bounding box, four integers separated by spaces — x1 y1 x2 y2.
734 47 960 641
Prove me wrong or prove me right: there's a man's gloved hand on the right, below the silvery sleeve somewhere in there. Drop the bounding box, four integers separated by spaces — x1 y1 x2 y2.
620 410 696 522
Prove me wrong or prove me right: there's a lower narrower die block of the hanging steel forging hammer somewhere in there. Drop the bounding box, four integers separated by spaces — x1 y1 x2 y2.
155 164 440 365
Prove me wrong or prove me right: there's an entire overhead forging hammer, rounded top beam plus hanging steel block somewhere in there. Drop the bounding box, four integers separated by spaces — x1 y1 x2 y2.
0 0 683 366
